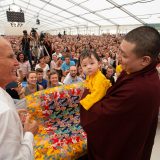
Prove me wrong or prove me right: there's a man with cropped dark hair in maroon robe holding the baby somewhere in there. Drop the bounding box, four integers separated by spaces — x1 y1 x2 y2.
80 26 160 160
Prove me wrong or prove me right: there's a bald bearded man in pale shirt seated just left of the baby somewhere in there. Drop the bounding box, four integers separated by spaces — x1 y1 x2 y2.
63 66 83 84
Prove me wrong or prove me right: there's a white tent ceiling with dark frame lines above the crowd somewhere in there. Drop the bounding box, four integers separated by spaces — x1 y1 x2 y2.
0 0 160 31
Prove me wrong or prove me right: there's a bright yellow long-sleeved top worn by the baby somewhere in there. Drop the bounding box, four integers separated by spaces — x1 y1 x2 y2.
80 77 111 110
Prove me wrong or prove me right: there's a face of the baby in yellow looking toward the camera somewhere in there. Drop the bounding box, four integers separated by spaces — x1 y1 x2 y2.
81 55 100 76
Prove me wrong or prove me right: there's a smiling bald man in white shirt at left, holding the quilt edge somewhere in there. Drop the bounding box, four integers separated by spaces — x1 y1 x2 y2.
0 37 38 160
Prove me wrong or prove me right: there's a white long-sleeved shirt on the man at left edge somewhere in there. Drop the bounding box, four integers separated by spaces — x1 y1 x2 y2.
0 87 33 160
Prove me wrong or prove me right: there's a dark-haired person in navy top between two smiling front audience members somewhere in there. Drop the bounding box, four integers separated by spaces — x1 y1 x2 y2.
36 68 48 89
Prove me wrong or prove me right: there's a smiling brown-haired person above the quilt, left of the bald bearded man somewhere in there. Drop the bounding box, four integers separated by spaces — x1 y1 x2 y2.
48 71 63 88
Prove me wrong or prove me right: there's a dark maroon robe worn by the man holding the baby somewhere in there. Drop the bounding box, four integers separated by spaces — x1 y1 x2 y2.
80 61 160 160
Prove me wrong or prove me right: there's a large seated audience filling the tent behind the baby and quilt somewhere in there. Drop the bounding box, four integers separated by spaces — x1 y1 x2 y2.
5 31 160 98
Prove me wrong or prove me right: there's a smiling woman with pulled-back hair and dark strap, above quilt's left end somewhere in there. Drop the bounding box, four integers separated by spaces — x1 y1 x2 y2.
22 71 43 96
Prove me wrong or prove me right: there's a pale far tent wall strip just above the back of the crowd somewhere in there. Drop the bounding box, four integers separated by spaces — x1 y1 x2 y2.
0 23 158 35
